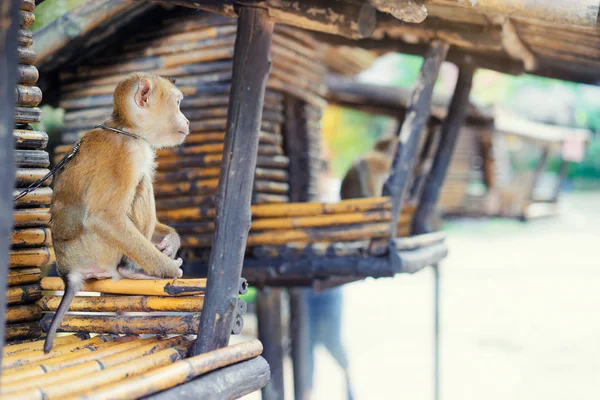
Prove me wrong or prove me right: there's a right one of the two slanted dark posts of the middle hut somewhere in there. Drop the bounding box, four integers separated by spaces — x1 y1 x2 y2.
412 64 475 235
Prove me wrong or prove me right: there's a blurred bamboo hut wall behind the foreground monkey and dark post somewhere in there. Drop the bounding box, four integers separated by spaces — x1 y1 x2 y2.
55 10 325 261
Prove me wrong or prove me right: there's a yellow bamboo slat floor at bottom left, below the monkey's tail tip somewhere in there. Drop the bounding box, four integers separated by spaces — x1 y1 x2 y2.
0 335 268 400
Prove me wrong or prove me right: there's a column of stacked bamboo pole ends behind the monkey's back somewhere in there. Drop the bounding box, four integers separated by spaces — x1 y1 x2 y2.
5 0 47 343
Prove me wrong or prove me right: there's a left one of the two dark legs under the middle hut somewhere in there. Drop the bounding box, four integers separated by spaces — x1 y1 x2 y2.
256 288 284 400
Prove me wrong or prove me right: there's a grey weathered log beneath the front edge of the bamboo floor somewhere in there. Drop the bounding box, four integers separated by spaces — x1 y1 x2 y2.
145 356 270 400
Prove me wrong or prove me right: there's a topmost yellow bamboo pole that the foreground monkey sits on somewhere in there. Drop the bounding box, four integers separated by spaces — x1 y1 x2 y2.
42 277 206 296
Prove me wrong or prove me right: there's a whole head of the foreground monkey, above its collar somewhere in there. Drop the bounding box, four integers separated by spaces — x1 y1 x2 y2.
113 73 190 148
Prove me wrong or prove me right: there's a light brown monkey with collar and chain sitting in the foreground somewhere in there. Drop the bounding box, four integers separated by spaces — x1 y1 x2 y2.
44 73 189 353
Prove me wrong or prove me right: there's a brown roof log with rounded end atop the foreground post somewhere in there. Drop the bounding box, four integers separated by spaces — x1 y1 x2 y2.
166 0 377 39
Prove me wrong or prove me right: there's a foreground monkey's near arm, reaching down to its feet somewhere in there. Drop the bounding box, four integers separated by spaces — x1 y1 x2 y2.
88 213 182 278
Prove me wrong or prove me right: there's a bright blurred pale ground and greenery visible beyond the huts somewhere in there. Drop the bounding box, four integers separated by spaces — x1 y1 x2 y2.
34 0 600 400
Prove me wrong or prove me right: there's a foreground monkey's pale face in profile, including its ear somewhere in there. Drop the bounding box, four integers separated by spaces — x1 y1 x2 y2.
134 78 190 148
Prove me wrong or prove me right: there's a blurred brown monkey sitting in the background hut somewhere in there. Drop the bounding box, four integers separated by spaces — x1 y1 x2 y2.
340 135 398 200
